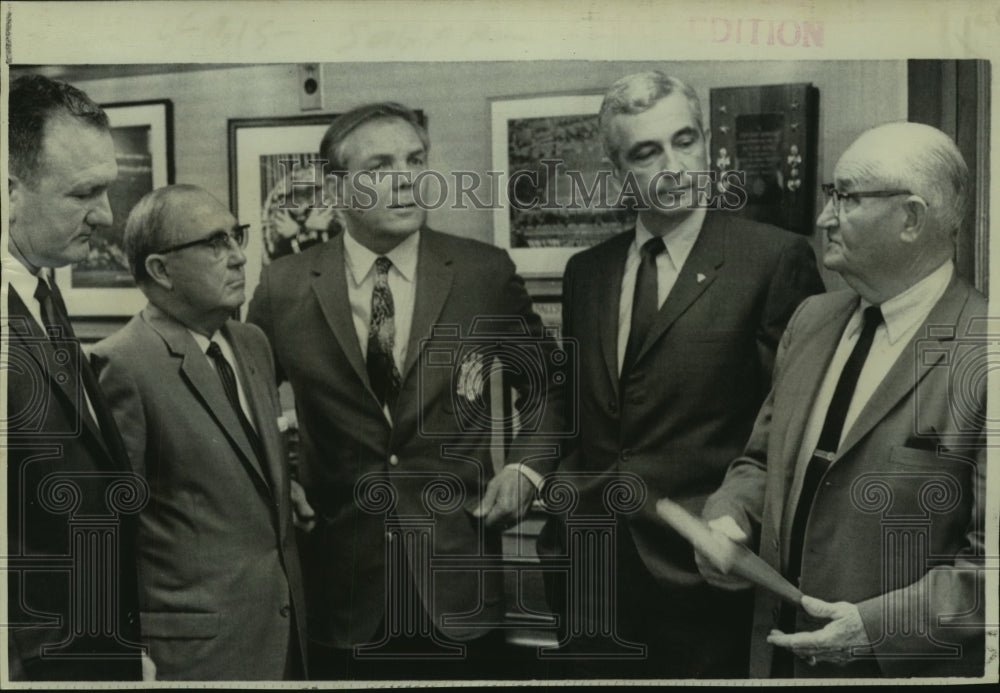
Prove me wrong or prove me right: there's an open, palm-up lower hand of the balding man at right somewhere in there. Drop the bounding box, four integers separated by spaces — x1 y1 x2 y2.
767 597 870 664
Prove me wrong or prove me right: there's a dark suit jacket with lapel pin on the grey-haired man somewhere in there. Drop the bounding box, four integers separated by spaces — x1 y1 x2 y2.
543 211 823 588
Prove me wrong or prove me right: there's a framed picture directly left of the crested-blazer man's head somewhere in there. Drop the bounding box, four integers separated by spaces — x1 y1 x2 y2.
227 113 340 302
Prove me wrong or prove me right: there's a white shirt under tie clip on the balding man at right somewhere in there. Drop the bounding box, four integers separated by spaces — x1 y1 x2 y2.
797 260 955 465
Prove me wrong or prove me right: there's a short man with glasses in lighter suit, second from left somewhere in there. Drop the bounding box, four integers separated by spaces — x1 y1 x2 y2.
94 185 305 680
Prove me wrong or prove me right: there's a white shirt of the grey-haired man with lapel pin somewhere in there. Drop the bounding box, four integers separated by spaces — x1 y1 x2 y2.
618 208 705 375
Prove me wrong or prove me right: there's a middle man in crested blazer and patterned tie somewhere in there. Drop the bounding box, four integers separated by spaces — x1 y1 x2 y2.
248 103 560 679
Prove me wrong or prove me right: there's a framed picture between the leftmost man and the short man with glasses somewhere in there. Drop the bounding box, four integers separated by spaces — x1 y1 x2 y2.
56 99 174 318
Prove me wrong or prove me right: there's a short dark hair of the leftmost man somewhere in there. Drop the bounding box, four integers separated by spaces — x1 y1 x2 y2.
7 75 110 185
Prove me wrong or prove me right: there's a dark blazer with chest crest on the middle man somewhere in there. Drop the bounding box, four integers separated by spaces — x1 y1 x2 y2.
247 228 559 647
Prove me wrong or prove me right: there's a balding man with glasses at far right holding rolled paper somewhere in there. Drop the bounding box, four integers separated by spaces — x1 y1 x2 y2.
699 123 996 678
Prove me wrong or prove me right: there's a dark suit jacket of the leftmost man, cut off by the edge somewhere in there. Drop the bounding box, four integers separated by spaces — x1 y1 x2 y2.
4 287 143 680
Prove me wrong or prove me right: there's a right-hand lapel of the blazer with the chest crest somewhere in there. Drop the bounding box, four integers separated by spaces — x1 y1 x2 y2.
400 229 454 382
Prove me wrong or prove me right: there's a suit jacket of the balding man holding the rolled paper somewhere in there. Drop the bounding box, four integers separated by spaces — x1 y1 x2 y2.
705 277 987 677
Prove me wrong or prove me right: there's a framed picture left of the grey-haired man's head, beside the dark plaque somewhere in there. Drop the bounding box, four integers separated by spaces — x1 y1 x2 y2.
490 93 634 276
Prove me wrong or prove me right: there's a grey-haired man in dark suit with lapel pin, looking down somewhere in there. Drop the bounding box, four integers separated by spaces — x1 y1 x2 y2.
540 72 823 678
